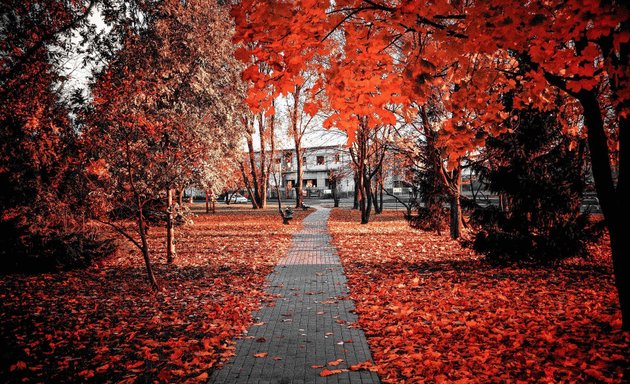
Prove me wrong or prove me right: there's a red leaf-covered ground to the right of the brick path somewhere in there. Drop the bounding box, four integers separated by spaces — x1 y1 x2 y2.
329 209 630 383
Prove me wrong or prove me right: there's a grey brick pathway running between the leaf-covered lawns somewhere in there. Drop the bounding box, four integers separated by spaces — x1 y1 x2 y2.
210 207 379 384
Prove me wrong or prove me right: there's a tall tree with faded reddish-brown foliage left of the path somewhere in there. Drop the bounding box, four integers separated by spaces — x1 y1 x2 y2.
88 1 242 287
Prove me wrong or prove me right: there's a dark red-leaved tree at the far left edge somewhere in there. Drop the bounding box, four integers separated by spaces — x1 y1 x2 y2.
0 1 131 269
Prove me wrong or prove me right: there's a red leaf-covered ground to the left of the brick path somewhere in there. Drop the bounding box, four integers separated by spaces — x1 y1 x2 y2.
0 206 305 382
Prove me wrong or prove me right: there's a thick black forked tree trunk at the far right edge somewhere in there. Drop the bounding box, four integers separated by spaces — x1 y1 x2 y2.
578 90 630 330
